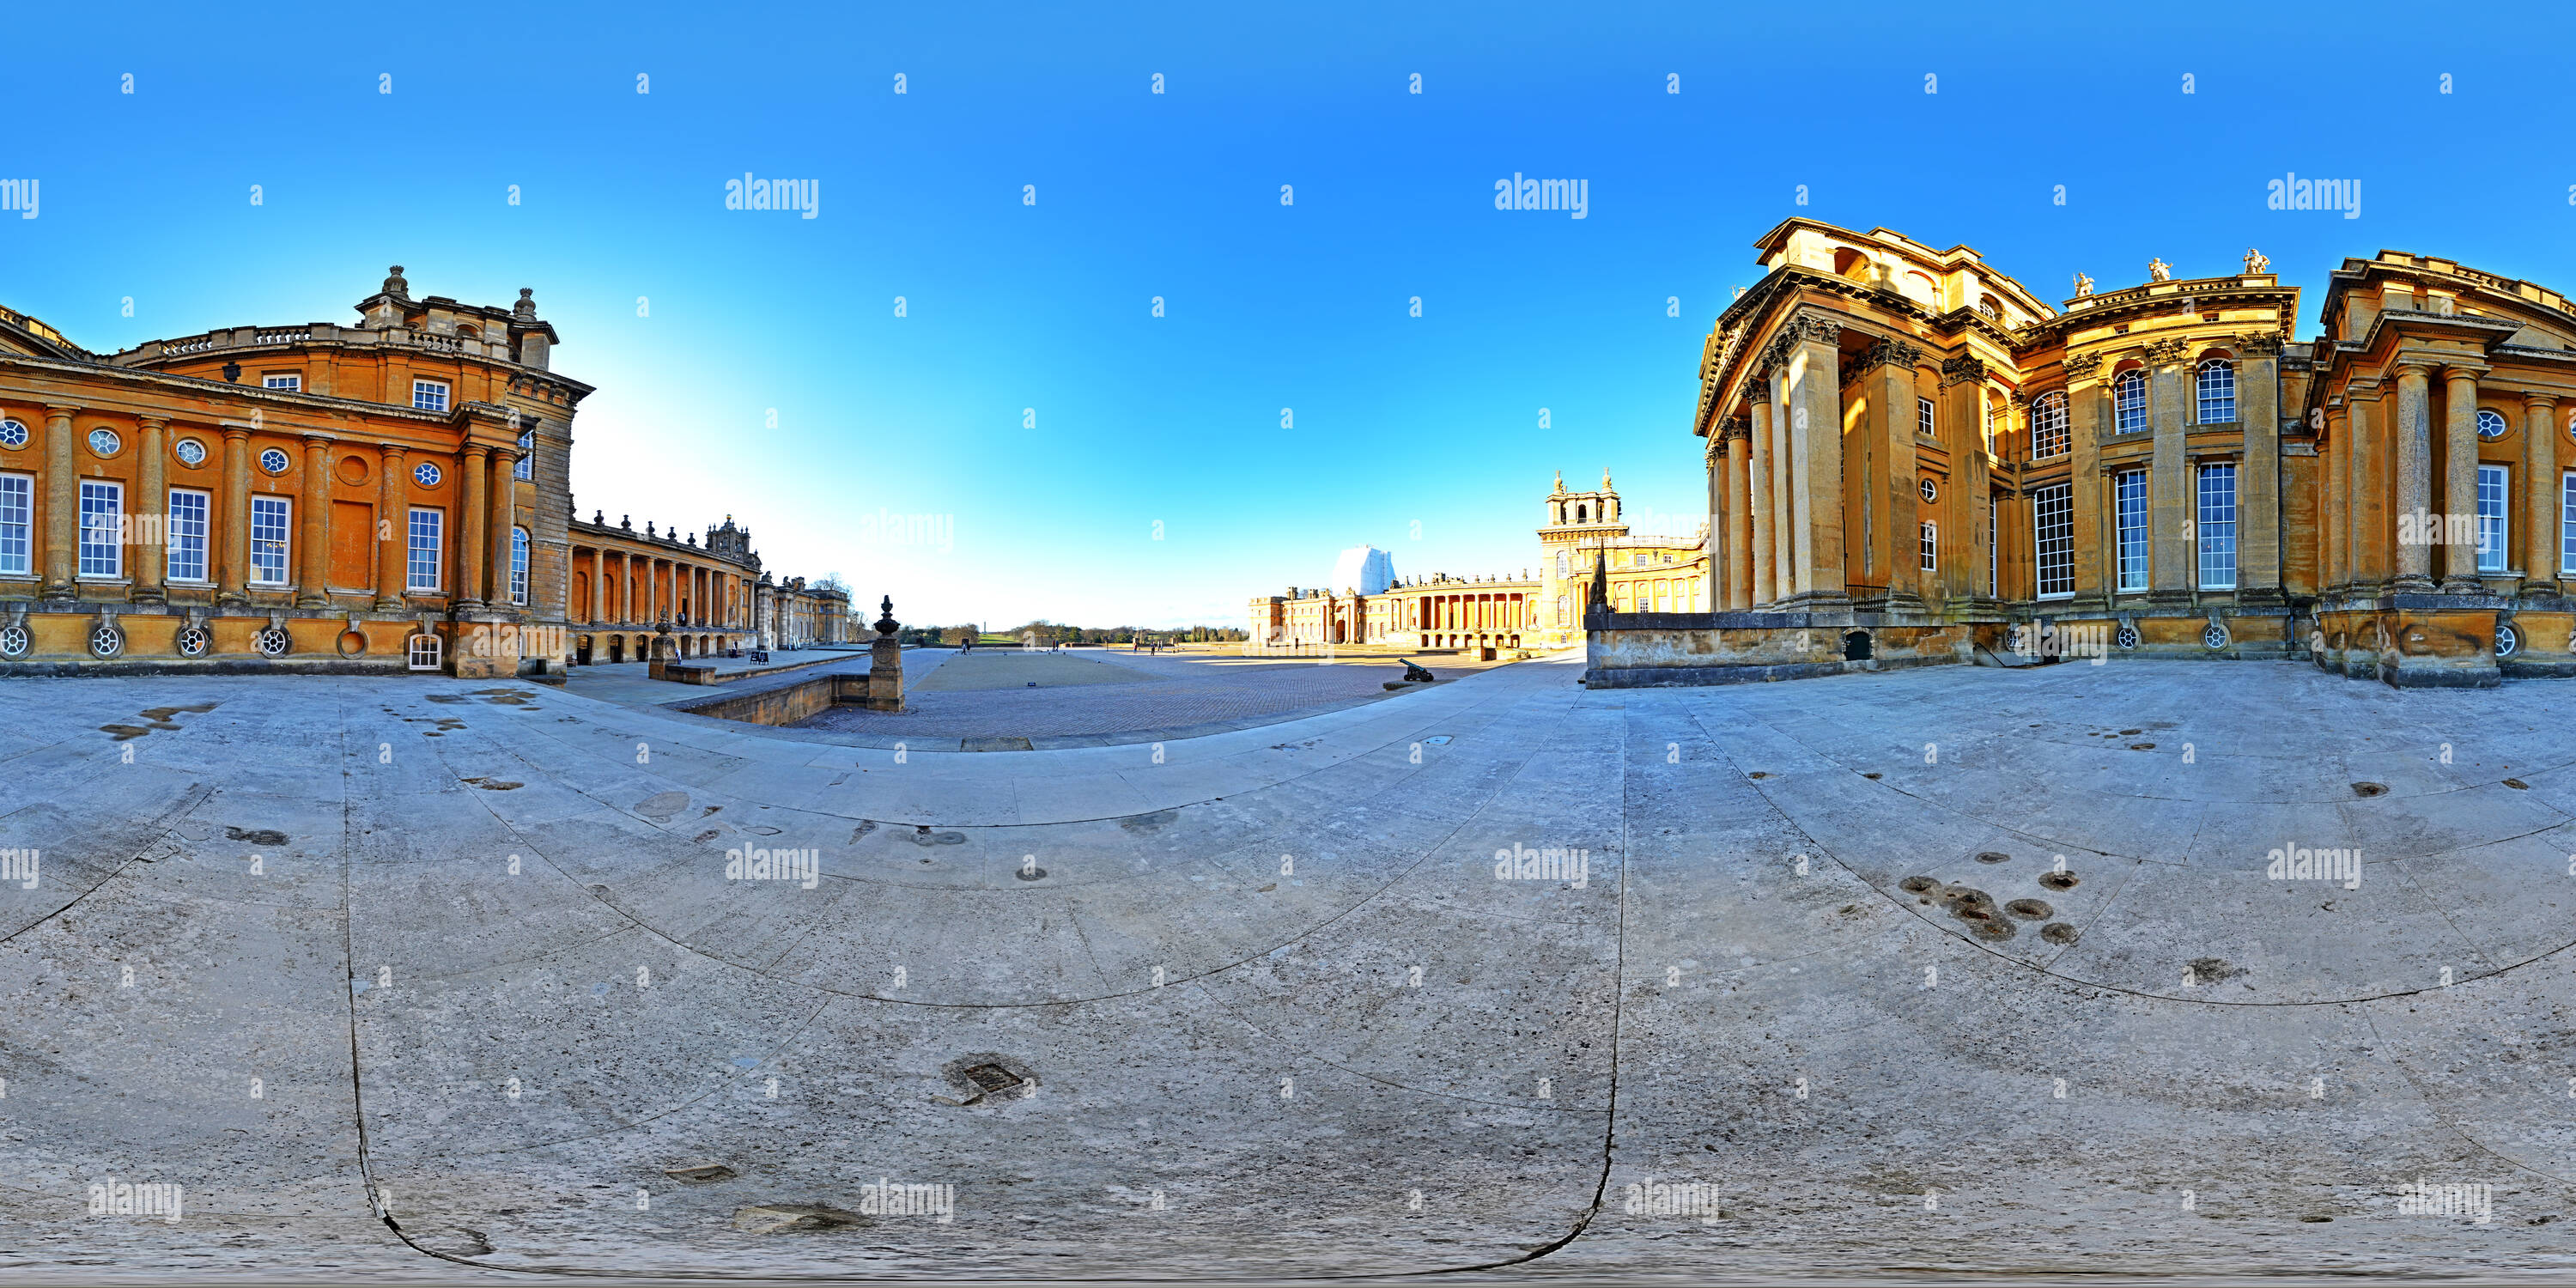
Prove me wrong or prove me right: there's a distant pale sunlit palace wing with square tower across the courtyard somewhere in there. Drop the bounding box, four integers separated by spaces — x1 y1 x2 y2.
1247 469 1710 652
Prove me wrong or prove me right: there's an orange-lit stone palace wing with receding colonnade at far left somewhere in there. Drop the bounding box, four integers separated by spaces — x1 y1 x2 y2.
0 268 853 675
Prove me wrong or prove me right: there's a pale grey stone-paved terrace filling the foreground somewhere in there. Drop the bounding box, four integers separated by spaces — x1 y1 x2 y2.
0 662 2576 1283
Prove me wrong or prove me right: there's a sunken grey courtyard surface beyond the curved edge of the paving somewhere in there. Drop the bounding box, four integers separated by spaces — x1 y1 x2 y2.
796 652 1484 737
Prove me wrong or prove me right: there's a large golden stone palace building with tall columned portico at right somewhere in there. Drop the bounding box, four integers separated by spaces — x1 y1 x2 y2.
1589 219 2576 685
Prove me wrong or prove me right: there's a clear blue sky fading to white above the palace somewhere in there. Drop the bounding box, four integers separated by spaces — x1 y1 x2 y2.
0 3 2576 626
